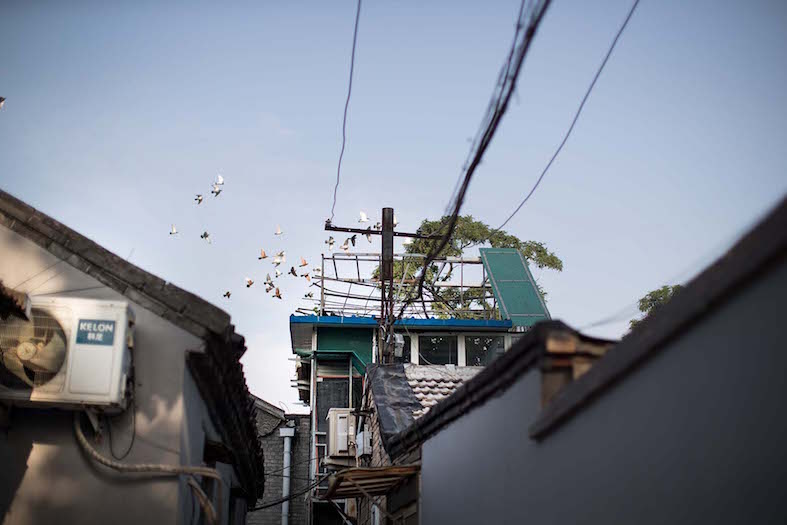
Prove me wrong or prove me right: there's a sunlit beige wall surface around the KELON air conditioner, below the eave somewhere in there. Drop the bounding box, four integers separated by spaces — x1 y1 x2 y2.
0 223 240 525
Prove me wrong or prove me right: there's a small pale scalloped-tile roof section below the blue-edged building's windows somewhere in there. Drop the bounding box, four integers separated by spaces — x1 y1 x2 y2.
404 364 483 419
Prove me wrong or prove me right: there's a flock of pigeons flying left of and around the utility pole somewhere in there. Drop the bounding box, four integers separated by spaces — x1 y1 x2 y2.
167 172 398 300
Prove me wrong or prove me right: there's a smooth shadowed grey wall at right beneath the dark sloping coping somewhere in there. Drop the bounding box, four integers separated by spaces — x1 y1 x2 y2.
421 255 787 524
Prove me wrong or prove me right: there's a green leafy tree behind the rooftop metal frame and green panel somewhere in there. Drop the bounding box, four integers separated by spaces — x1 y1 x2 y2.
374 215 563 318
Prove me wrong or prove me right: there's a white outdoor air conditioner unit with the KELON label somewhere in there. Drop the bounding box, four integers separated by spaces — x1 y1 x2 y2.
0 297 134 412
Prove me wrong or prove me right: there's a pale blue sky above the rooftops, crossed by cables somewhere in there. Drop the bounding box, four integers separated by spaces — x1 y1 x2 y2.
0 0 787 409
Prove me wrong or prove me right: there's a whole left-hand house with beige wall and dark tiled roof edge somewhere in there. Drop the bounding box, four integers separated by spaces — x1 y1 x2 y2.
0 191 263 525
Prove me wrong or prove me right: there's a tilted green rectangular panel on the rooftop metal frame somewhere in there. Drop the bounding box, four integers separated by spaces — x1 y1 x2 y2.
480 248 550 326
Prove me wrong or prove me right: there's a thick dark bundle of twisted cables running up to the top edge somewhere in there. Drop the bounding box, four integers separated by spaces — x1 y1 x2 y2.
400 0 551 322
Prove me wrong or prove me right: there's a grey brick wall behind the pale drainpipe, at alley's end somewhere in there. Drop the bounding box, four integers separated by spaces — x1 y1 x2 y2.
246 410 310 525
